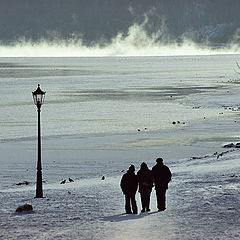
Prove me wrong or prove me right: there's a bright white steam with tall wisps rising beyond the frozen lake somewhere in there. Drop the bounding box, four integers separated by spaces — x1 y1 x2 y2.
0 21 240 57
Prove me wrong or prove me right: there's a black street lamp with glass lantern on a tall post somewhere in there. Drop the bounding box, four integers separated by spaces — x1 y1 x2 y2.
32 84 46 198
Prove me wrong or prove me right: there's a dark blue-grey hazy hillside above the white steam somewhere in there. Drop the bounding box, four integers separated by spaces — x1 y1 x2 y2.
0 0 240 45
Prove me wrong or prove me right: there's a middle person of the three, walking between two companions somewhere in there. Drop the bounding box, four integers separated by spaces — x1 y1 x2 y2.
137 162 153 212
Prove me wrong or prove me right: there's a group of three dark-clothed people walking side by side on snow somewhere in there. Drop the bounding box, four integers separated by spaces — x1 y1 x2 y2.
120 158 172 214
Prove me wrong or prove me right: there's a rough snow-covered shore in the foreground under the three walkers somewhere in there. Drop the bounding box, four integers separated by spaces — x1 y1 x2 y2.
0 150 240 240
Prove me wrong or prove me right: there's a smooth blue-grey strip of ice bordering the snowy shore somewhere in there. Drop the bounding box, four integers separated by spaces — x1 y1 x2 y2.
0 112 239 189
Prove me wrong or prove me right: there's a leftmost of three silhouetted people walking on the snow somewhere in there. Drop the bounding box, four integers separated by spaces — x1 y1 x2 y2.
120 165 138 214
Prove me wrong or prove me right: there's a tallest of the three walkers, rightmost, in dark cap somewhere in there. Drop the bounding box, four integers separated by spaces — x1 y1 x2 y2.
152 158 172 211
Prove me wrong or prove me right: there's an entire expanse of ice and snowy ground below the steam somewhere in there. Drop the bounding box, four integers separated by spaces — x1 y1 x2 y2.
0 55 240 239
